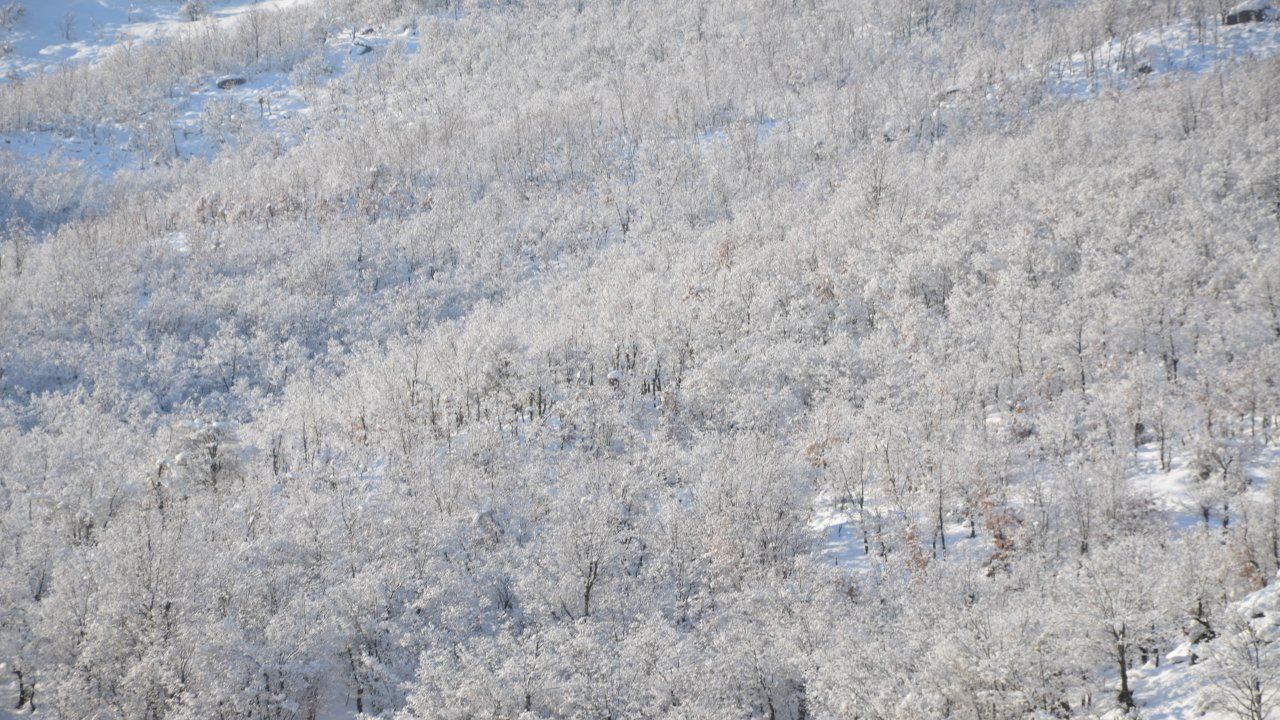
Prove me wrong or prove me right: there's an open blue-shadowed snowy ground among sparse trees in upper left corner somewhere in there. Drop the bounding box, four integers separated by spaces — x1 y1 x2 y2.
0 0 419 179
